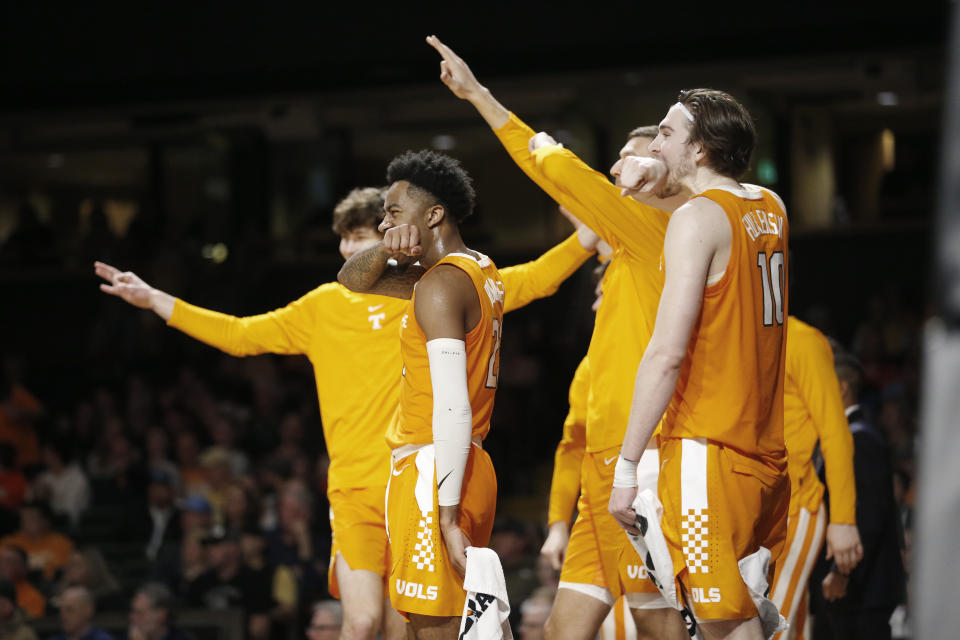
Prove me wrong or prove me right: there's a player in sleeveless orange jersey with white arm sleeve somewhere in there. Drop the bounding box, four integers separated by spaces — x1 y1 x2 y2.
338 151 504 640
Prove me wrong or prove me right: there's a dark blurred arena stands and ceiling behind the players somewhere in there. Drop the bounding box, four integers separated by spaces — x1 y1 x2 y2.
0 2 956 640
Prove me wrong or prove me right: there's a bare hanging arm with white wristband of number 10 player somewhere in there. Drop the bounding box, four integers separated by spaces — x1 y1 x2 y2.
608 199 715 533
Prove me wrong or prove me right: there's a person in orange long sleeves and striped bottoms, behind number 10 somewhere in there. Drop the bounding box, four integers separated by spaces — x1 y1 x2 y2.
770 316 863 640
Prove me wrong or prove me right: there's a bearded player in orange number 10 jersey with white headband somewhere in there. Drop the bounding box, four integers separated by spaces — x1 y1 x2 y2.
609 89 790 639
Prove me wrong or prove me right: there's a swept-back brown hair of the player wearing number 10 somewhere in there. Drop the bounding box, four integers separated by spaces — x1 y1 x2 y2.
677 89 757 180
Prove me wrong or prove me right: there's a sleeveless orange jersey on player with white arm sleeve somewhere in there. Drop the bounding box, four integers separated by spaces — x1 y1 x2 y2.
387 253 503 449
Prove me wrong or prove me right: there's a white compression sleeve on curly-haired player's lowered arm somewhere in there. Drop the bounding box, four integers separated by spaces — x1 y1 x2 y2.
427 338 473 507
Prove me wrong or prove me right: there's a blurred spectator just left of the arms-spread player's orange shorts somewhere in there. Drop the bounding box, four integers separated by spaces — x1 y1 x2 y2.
267 481 330 603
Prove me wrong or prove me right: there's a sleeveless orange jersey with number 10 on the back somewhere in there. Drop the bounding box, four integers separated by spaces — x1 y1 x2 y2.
662 188 788 468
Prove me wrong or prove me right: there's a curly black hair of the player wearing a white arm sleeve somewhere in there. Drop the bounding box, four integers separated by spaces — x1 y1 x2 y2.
387 149 476 223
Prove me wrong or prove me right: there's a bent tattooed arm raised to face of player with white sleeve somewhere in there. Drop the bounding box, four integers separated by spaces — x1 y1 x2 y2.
337 225 425 300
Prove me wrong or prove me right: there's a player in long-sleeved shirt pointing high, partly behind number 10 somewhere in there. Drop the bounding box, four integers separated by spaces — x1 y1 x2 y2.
427 36 686 640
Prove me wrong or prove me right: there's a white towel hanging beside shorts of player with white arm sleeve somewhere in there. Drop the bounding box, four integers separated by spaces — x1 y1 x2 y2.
459 547 513 640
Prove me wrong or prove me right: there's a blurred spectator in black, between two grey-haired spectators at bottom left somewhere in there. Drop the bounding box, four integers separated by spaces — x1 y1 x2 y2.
187 528 274 639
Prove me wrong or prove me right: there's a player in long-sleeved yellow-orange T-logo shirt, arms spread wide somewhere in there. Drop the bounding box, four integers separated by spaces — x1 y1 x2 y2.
95 187 597 640
